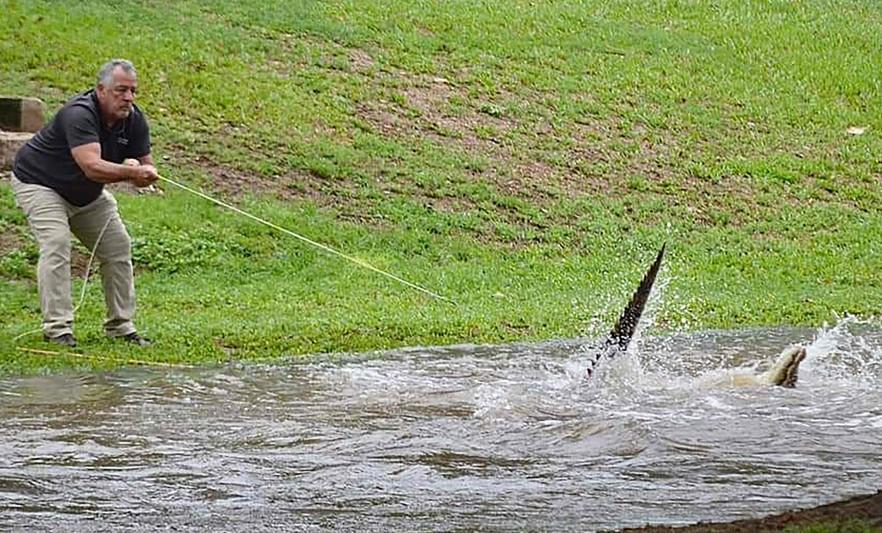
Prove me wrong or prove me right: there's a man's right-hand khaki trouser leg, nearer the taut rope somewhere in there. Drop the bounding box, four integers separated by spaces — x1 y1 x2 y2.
70 190 135 337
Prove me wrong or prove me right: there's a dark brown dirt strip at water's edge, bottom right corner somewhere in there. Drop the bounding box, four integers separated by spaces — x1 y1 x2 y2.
622 490 882 533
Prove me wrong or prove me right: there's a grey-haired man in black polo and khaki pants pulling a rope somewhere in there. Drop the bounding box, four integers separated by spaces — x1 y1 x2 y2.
12 59 159 347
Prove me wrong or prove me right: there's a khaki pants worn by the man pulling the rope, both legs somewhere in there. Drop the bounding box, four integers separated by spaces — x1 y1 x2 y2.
12 176 135 337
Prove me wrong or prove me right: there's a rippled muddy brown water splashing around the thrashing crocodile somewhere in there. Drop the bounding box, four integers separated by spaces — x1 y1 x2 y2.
0 320 882 531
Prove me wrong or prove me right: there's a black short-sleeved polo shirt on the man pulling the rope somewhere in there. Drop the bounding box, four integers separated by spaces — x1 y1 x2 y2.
12 90 150 207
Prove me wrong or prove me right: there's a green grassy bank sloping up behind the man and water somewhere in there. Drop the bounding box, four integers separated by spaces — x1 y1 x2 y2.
0 0 882 372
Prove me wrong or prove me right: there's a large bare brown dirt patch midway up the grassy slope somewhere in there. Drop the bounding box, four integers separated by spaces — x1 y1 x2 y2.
357 67 750 223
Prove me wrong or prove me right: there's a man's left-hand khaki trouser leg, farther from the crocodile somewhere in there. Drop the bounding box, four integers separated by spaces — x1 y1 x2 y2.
12 176 73 338
